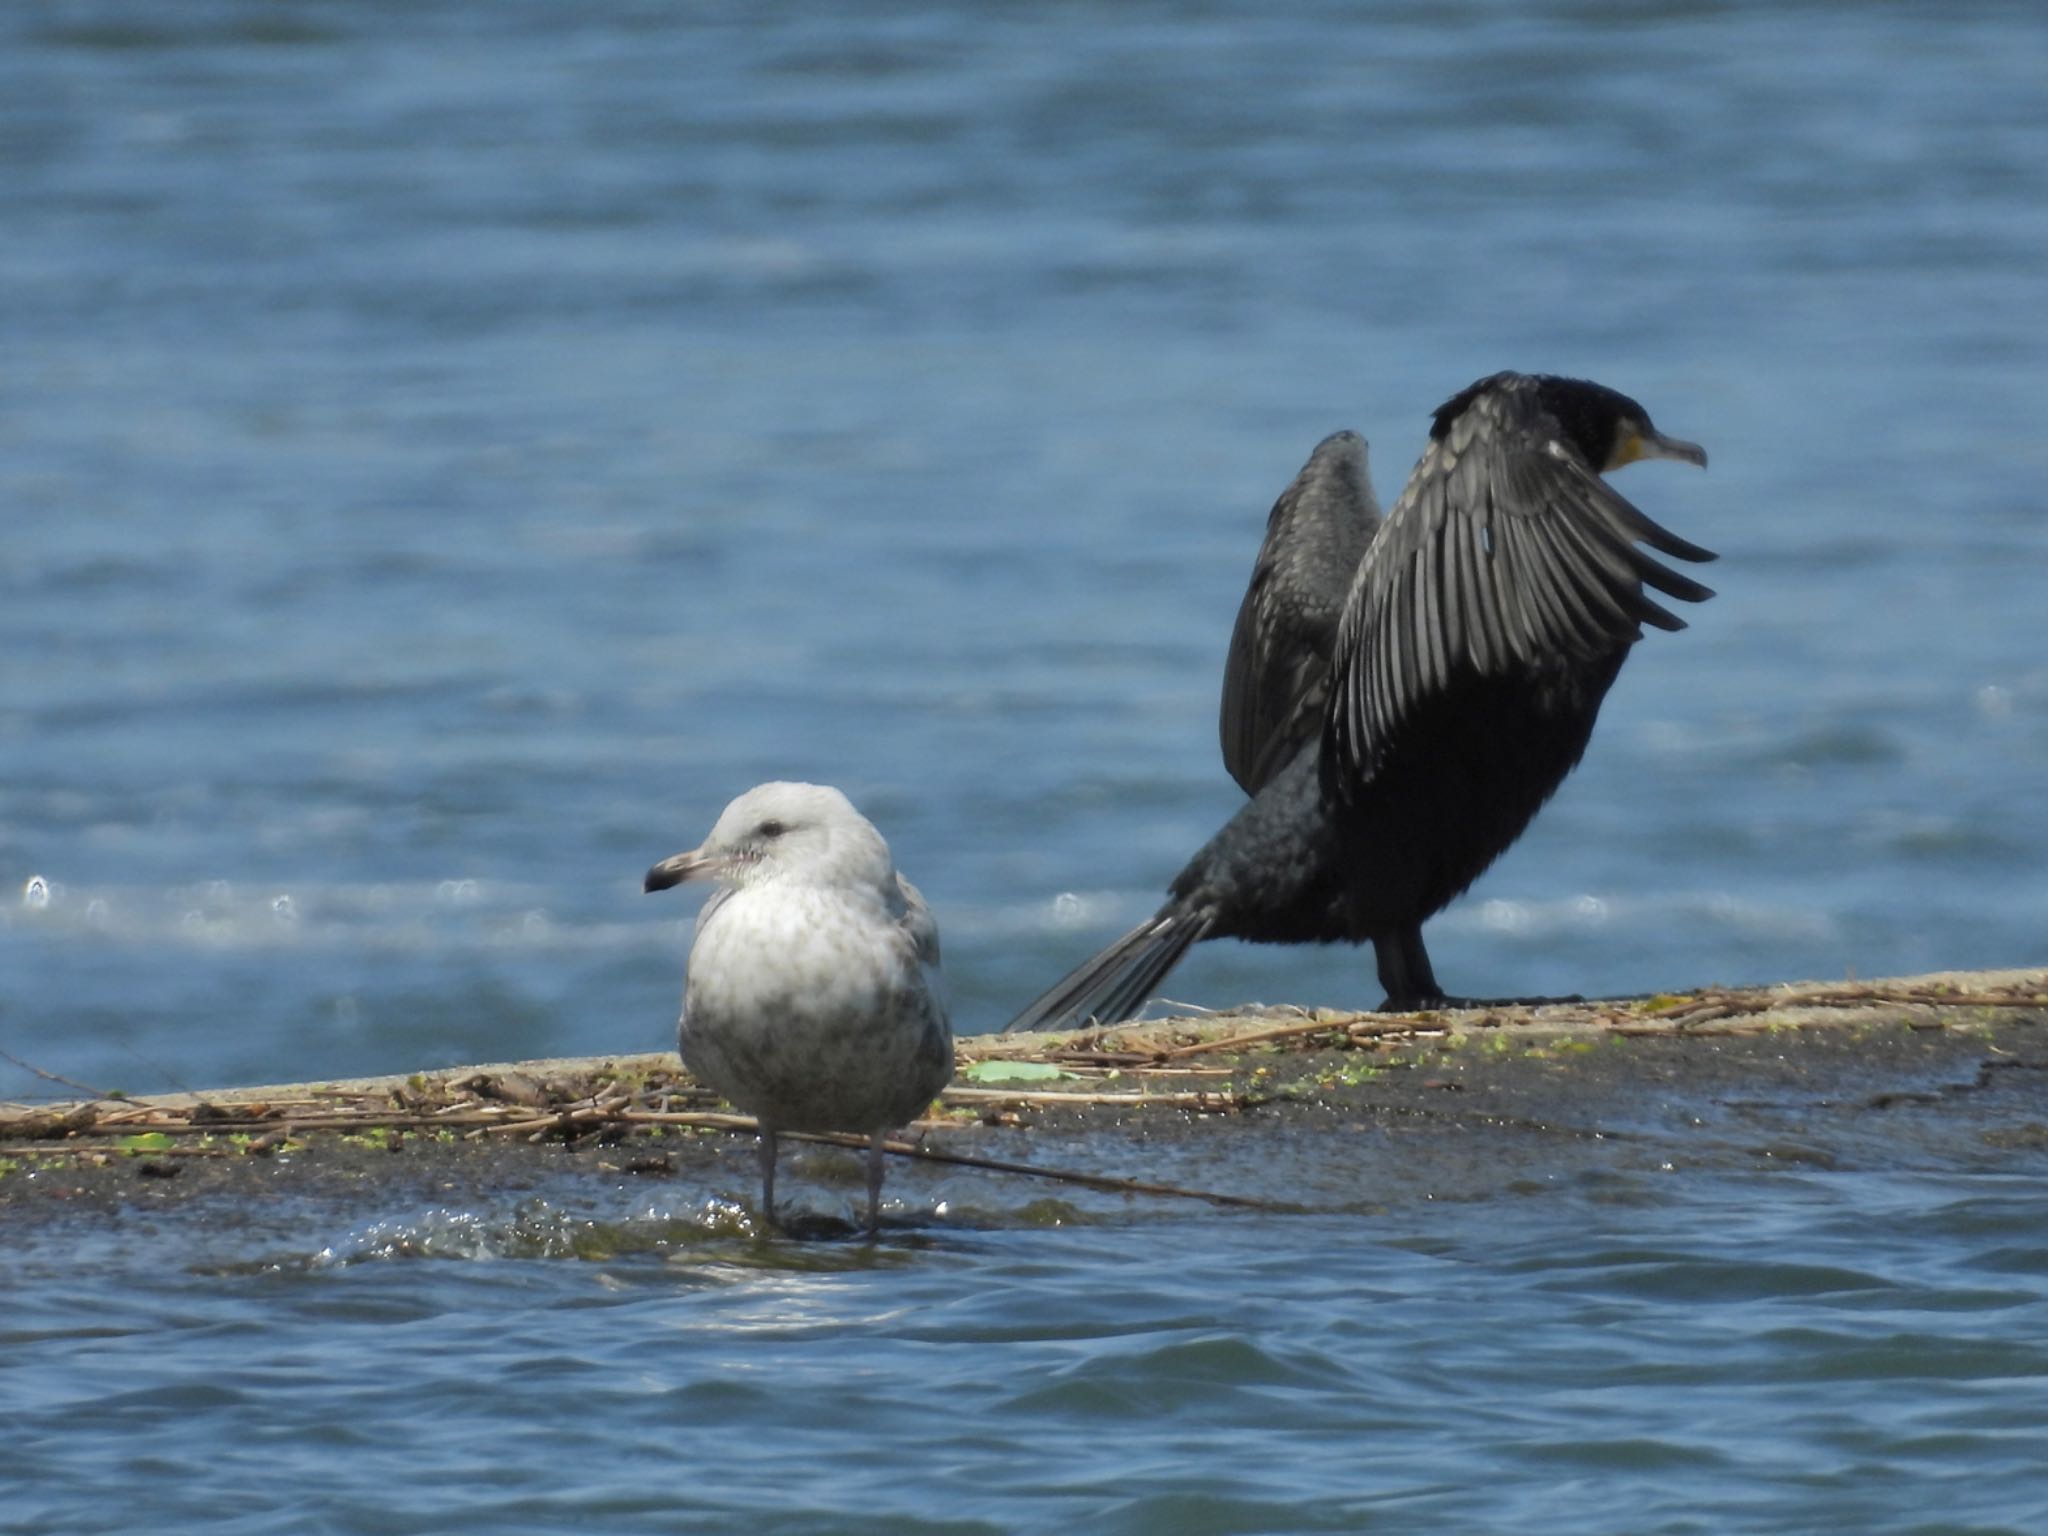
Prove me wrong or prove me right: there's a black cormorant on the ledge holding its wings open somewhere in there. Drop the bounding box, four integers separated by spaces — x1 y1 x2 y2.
1006 373 1714 1030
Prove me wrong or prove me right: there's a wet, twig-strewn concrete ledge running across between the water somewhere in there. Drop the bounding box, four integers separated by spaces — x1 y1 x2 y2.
0 969 2048 1241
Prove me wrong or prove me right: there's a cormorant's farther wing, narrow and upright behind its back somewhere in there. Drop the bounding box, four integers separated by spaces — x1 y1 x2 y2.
1223 432 1380 795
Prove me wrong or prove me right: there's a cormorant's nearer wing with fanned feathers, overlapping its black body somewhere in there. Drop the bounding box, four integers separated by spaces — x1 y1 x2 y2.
1323 395 1714 793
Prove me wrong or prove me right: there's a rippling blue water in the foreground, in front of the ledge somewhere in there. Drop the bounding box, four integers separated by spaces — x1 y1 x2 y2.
12 1161 2048 1532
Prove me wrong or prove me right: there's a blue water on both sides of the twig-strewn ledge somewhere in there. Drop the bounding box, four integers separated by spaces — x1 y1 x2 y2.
0 0 2048 1532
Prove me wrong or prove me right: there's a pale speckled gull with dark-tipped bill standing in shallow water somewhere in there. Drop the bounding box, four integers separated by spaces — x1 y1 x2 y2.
647 782 952 1217
